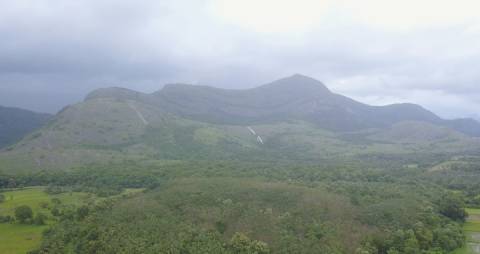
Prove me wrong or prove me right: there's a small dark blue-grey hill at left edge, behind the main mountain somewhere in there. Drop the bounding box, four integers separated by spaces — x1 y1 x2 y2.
0 106 52 148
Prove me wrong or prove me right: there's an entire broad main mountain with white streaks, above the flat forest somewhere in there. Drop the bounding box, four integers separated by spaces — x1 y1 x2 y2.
0 75 480 171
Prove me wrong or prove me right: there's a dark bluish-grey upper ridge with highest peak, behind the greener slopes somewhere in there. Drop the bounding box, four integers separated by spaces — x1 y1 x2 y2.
87 74 480 136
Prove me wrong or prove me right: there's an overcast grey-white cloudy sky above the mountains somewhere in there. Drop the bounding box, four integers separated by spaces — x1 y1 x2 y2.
0 0 480 118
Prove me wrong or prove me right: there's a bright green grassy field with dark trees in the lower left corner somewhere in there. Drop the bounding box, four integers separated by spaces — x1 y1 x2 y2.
0 187 91 254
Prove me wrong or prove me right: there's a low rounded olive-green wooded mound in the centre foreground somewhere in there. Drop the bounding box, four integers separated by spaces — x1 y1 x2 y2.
35 178 363 253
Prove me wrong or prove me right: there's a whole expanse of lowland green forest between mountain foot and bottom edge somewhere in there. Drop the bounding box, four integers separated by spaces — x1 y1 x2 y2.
0 161 472 254
